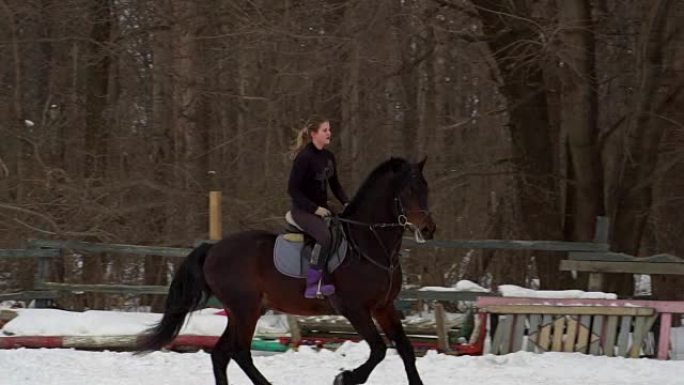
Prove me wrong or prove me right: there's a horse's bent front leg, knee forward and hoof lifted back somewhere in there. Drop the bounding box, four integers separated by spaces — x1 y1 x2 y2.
334 306 387 385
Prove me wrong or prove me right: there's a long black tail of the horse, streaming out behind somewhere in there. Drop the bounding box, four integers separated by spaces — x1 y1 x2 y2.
136 243 212 354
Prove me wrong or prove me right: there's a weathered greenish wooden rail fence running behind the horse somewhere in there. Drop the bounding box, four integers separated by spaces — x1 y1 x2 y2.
0 217 684 303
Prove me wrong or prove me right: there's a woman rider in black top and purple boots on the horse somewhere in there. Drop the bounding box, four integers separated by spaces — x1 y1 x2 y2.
287 117 349 298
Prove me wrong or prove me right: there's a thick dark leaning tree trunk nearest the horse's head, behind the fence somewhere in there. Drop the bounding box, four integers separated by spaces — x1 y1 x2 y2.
474 0 572 289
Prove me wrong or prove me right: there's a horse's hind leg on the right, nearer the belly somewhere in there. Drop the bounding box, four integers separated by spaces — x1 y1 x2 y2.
226 296 271 385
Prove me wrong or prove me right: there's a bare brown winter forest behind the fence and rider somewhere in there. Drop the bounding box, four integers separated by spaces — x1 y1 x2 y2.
0 0 684 306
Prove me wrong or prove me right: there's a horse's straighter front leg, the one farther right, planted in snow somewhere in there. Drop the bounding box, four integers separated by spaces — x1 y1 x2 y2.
373 305 423 385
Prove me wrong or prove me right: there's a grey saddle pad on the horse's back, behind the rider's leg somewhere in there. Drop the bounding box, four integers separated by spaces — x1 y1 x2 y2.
273 234 347 278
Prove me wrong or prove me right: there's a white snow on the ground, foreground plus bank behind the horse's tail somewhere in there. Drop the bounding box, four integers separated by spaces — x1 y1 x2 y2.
0 309 684 385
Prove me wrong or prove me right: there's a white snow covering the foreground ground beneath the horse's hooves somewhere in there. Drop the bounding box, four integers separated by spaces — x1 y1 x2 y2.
0 343 684 385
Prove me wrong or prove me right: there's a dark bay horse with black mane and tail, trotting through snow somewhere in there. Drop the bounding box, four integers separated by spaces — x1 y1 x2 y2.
136 158 436 385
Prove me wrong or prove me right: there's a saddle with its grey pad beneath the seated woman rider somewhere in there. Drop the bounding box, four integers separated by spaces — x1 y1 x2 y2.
273 211 348 278
